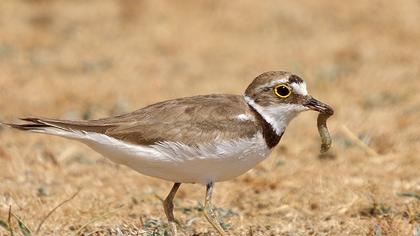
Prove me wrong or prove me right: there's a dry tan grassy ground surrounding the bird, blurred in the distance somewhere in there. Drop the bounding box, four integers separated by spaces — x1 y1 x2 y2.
0 0 420 235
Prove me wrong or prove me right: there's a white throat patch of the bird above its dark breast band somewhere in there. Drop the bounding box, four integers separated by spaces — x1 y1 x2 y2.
244 96 302 135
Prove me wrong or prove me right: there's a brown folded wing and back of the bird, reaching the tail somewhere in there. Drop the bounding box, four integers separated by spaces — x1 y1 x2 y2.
11 95 259 145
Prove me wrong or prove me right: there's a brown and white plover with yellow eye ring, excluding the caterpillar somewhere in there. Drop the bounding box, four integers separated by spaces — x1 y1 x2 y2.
3 71 331 235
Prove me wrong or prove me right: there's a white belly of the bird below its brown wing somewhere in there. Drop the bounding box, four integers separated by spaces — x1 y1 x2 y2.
81 133 270 184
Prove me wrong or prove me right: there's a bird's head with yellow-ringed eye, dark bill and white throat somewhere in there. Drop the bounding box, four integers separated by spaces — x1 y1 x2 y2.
245 71 333 134
